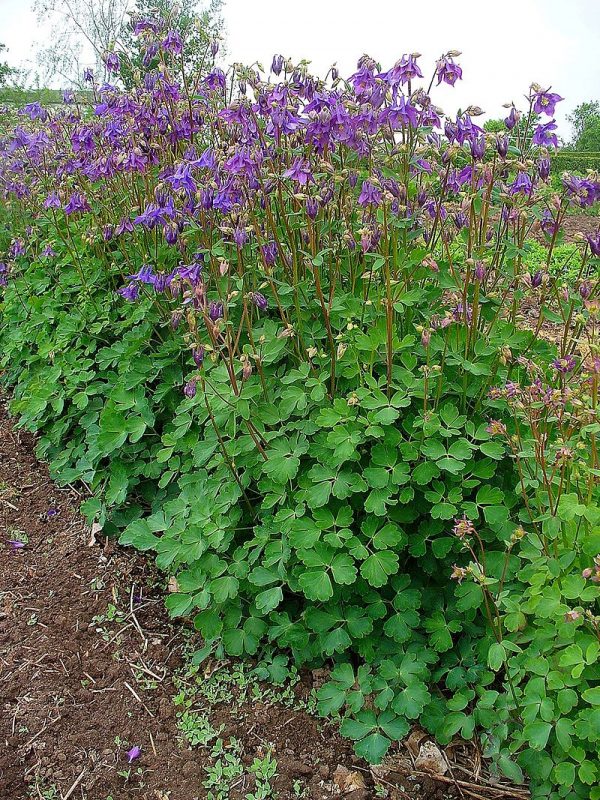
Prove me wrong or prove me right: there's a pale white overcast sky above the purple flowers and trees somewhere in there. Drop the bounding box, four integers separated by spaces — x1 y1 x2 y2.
0 0 600 136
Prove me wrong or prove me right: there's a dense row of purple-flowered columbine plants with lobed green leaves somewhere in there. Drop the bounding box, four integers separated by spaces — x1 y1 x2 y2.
0 20 600 798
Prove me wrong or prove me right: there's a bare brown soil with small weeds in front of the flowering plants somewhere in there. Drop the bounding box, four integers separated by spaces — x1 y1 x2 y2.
0 405 528 800
